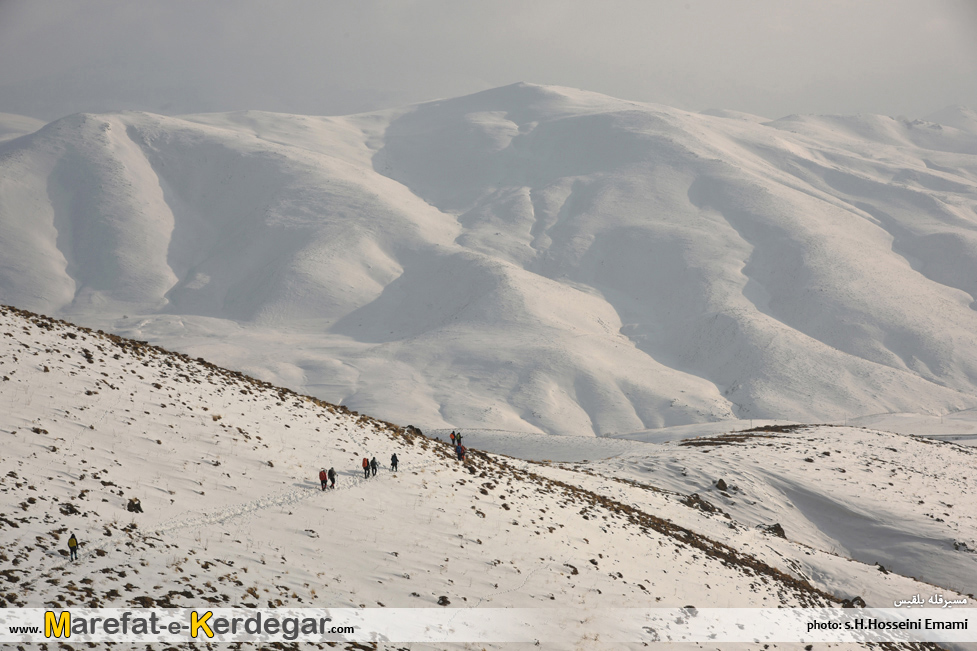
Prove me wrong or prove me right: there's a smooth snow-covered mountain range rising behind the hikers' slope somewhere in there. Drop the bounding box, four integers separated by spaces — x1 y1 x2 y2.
0 84 977 435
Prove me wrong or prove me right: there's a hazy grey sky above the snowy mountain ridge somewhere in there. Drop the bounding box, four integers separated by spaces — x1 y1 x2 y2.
0 0 977 119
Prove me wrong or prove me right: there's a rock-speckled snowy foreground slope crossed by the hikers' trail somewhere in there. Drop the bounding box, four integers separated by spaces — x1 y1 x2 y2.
0 308 975 649
